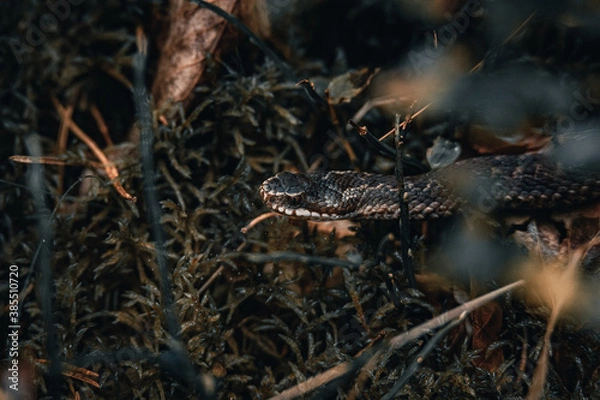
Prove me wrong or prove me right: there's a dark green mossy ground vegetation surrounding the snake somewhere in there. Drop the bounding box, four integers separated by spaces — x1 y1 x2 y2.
0 0 600 399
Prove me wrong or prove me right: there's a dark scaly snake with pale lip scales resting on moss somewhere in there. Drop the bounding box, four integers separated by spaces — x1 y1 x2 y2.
259 153 600 221
